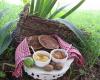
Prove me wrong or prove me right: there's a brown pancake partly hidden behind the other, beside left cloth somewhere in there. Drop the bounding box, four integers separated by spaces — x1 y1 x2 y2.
27 35 43 49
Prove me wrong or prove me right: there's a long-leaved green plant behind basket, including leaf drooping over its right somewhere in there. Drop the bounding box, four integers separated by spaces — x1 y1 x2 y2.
23 0 86 45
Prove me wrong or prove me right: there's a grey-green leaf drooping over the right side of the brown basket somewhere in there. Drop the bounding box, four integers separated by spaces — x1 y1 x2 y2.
57 19 86 46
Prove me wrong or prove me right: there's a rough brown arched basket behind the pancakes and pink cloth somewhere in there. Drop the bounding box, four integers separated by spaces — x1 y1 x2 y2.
13 16 79 46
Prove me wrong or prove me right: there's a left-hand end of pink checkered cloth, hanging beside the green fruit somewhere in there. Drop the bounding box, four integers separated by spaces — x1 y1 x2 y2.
12 38 31 78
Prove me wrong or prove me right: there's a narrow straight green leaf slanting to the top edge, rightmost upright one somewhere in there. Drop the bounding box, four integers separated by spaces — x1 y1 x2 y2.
60 0 85 19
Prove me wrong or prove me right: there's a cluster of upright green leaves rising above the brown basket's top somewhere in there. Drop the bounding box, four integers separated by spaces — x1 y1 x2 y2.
23 0 85 19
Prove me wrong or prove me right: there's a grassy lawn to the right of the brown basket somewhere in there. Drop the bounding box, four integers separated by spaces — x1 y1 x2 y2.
66 10 100 66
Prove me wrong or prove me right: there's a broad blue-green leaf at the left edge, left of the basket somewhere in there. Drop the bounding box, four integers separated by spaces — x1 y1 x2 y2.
0 10 15 55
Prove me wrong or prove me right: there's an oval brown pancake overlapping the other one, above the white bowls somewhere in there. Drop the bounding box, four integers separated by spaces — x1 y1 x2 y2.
38 35 59 49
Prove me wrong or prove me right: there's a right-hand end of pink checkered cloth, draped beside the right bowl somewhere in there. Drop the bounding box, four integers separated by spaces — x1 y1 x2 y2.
54 35 84 66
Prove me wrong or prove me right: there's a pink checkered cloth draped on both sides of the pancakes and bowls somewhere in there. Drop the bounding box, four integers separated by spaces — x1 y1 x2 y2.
13 35 84 77
